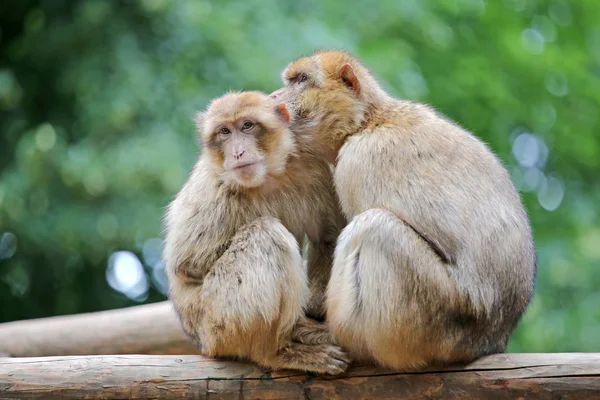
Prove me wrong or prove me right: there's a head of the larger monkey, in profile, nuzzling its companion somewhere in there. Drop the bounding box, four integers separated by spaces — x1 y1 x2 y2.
270 51 378 162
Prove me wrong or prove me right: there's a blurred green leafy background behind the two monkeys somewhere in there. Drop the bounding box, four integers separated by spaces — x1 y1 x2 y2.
0 0 600 352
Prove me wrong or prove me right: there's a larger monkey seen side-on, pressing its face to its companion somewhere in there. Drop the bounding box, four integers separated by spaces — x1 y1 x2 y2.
271 51 537 370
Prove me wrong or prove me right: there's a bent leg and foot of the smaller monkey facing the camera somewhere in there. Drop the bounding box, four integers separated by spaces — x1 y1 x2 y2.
173 217 348 373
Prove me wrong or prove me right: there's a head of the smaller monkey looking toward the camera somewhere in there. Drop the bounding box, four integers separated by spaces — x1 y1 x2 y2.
196 91 296 188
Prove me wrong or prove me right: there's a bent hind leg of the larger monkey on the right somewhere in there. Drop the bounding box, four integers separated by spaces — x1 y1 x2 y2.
327 209 480 369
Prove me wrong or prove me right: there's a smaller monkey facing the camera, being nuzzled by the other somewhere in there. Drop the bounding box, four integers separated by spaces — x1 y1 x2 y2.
164 92 349 374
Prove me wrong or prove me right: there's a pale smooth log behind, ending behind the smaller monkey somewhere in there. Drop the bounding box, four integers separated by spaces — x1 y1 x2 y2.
0 301 198 356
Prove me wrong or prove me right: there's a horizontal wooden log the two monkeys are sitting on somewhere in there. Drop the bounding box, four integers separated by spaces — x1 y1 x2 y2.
0 353 600 400
